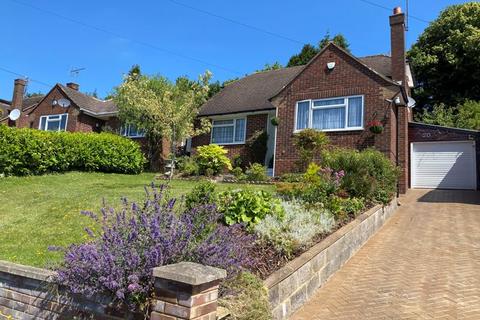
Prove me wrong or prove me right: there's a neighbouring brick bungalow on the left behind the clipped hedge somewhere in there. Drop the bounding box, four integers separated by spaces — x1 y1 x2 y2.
0 79 170 165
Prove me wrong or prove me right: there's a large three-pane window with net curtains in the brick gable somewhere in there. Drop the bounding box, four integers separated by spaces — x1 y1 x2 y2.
295 96 363 131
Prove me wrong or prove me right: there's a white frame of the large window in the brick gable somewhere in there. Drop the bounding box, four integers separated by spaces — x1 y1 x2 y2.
293 95 365 133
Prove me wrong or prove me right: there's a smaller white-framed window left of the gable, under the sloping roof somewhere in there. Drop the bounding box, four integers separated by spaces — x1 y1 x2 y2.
211 118 247 144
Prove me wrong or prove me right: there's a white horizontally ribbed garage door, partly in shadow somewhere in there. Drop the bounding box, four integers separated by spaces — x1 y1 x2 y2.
411 141 477 189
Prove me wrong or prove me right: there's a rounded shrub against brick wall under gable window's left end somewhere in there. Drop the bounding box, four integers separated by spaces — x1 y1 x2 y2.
293 129 329 171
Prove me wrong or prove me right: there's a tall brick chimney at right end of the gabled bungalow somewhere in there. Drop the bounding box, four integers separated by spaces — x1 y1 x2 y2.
390 7 408 89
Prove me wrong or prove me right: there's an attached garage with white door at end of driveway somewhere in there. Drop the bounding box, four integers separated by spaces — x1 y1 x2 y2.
408 122 480 190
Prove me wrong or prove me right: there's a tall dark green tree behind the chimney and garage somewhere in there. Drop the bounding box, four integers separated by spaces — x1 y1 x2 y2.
408 2 480 107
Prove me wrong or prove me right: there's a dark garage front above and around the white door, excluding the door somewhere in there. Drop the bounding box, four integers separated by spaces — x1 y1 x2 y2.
408 122 480 188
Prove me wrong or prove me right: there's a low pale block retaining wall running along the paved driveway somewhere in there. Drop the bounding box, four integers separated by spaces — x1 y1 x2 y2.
265 199 397 320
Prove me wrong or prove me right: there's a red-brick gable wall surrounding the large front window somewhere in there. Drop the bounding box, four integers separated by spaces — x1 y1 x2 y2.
273 46 399 175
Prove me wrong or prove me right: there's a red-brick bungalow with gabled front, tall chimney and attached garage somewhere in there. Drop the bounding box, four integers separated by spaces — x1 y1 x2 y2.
192 8 479 193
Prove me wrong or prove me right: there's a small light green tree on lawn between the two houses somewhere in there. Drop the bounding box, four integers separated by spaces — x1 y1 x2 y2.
114 72 211 169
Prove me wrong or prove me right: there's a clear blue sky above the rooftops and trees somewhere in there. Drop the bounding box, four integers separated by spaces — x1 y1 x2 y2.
0 0 466 99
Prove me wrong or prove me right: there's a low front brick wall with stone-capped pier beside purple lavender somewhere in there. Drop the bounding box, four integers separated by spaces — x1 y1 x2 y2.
0 261 228 320
